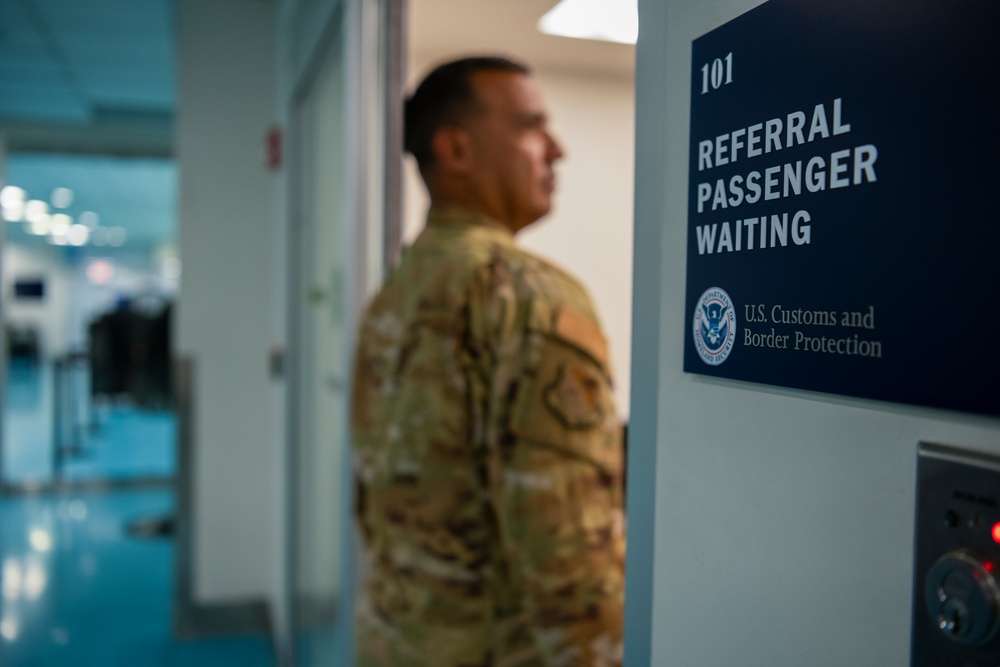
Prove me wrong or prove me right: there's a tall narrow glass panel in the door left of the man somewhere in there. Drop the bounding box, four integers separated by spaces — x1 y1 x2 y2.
290 13 351 665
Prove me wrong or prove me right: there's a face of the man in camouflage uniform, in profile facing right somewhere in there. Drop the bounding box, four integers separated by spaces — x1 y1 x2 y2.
466 71 563 232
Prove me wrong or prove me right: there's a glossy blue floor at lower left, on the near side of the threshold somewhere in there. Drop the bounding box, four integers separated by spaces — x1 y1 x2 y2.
0 488 275 667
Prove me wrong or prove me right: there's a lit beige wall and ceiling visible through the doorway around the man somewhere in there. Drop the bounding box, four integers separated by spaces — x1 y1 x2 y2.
403 0 635 421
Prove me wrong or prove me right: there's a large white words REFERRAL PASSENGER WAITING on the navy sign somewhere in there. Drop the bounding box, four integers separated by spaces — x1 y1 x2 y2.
695 97 878 255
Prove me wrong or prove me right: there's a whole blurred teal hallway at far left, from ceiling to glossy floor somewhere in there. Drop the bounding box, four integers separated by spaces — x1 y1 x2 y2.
0 0 274 667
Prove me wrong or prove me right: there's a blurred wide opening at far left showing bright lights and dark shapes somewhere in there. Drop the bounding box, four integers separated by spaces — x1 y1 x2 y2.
0 153 180 490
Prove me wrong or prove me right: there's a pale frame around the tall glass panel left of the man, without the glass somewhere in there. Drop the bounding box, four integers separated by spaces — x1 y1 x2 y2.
277 0 407 667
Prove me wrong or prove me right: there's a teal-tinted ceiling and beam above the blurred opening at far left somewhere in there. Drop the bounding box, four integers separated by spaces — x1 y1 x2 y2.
0 0 175 155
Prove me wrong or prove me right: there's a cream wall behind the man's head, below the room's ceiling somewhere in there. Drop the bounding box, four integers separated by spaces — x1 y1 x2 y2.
404 64 635 417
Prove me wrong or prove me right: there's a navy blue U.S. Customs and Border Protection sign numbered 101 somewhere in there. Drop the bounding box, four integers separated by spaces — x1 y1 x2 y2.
684 0 1000 415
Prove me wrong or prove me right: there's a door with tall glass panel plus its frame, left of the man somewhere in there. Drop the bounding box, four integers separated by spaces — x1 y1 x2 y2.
288 2 402 666
